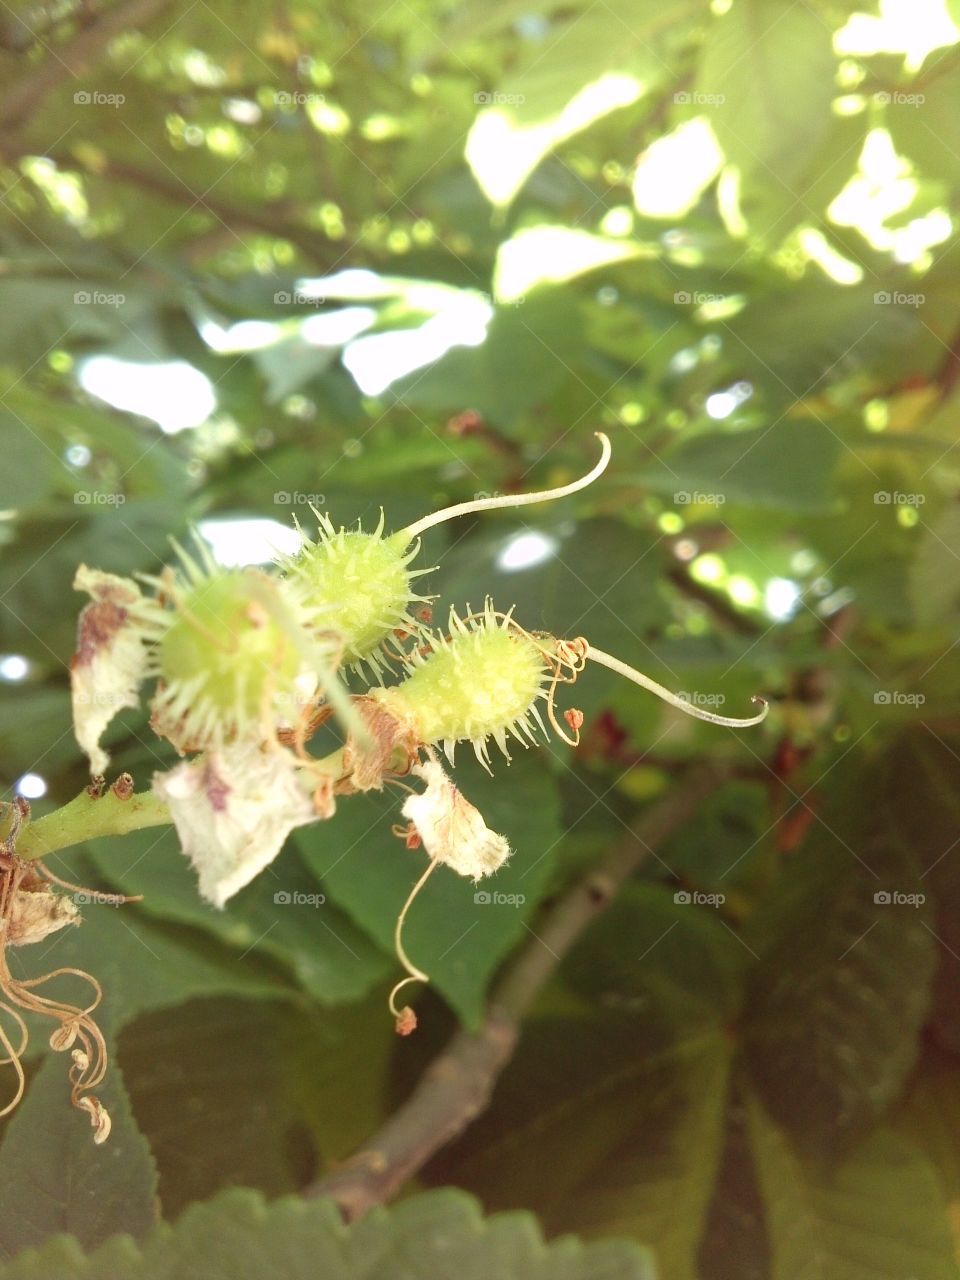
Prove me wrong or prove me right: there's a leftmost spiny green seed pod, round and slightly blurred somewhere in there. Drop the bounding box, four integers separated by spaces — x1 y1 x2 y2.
154 552 316 750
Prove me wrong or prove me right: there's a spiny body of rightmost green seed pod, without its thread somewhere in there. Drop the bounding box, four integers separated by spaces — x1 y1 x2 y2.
370 600 553 765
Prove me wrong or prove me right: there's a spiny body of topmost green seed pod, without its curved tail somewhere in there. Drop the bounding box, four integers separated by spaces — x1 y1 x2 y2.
280 512 429 675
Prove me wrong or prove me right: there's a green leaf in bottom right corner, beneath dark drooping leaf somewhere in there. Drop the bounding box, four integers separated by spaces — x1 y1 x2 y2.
750 1101 960 1280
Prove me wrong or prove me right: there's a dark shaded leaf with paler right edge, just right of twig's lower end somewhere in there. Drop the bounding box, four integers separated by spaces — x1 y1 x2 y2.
439 1012 730 1280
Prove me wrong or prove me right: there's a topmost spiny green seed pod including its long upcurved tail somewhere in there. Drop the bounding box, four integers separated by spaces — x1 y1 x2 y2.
279 433 611 678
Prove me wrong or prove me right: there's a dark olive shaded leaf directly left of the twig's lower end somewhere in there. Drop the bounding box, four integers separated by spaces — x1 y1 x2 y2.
119 991 397 1219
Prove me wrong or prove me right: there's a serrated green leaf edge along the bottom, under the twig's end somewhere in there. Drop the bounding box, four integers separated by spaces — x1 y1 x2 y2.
0 1190 655 1280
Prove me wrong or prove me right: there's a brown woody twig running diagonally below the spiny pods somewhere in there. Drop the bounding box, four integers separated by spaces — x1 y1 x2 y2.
305 767 728 1221
